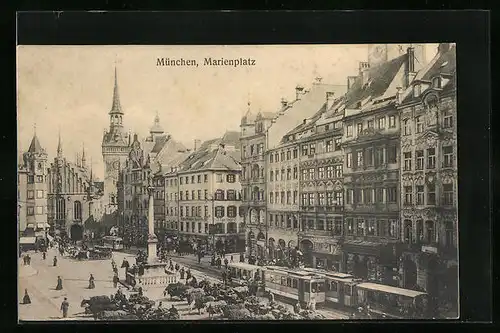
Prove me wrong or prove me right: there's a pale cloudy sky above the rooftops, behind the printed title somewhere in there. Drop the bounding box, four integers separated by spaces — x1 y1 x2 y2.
17 44 437 178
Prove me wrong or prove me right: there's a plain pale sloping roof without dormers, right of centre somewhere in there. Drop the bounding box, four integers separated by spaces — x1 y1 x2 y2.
268 83 347 148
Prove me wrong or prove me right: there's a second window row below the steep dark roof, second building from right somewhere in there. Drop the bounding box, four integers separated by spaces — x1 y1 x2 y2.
346 145 397 169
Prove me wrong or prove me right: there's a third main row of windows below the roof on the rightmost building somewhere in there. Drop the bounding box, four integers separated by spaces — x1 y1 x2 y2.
403 184 453 206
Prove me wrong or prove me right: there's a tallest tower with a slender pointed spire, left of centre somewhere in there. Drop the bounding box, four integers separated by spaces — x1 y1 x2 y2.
102 67 130 214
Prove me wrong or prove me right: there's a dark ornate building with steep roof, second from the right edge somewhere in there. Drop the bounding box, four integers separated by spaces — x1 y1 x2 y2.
342 48 416 285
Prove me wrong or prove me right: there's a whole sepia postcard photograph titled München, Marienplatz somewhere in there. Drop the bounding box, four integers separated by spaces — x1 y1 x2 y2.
16 42 460 322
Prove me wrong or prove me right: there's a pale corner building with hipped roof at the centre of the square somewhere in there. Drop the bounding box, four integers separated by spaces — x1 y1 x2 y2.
177 132 245 253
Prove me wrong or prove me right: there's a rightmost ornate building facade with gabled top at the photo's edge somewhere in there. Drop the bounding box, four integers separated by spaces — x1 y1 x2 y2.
399 43 458 315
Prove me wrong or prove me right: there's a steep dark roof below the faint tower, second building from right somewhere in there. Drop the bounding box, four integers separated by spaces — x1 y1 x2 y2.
346 54 408 109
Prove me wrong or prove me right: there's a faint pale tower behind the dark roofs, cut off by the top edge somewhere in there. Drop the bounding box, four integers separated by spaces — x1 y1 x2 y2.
368 44 426 71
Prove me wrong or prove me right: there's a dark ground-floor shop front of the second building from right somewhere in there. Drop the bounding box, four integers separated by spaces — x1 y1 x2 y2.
342 241 399 286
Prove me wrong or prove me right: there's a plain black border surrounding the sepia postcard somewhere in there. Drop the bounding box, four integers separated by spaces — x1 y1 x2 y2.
5 11 493 331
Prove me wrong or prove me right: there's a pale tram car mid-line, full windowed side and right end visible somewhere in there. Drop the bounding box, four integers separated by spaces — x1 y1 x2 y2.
264 266 325 304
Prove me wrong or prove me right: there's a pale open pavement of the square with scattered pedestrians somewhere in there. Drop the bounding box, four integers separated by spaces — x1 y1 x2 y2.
18 250 347 321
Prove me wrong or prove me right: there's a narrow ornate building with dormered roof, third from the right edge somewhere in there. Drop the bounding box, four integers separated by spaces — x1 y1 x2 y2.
291 89 344 271
